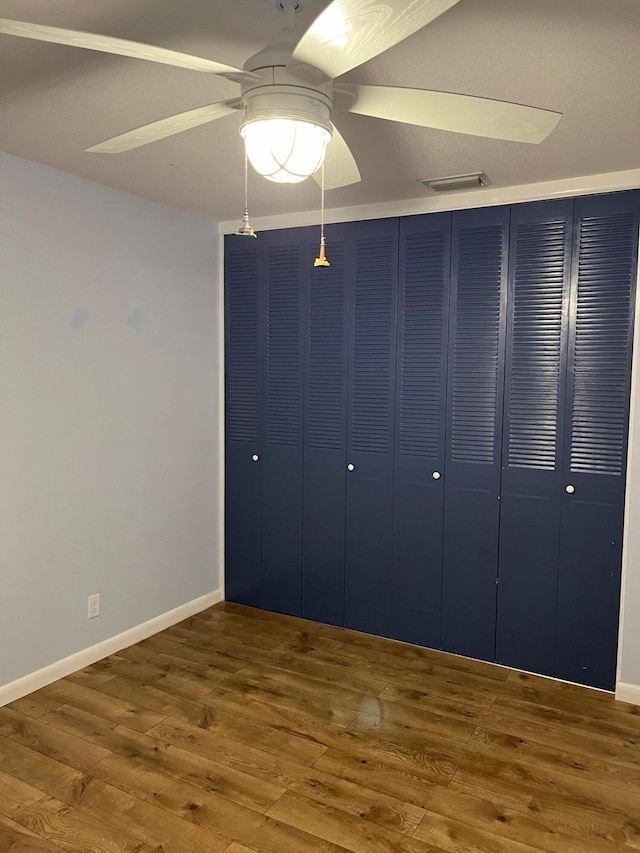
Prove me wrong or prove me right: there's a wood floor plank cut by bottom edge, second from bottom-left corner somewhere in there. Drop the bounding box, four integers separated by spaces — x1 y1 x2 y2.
15 797 158 853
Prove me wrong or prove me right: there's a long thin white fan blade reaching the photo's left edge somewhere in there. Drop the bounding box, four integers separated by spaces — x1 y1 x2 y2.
0 18 256 79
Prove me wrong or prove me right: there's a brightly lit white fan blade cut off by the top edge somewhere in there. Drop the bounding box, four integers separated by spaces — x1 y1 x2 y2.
293 0 459 79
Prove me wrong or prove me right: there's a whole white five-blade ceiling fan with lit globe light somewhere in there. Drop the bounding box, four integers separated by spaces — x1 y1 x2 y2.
0 0 561 189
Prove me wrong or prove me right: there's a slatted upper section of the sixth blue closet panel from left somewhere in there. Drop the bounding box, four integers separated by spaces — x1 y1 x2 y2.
451 226 503 465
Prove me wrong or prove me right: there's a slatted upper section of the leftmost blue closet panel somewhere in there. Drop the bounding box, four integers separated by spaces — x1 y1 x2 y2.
226 252 261 441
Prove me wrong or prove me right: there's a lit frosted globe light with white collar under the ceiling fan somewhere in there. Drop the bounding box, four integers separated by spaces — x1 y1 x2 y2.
240 85 333 184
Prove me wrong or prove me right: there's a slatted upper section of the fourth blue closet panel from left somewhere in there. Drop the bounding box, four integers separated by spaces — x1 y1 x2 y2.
351 237 395 453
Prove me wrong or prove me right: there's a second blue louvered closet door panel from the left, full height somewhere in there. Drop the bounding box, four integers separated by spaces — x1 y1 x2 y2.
256 229 309 616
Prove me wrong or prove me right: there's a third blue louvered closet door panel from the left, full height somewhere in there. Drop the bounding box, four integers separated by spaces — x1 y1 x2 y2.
302 225 348 625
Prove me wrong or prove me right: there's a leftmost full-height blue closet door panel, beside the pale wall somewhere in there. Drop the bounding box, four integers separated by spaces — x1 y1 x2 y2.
225 236 264 607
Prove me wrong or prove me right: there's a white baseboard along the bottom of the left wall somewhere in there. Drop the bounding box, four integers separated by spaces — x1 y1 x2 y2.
0 589 223 708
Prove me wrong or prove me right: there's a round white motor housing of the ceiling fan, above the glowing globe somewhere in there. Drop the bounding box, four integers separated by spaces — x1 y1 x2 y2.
241 44 333 135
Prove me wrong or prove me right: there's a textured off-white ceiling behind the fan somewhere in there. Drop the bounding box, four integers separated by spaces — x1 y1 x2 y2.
0 0 640 220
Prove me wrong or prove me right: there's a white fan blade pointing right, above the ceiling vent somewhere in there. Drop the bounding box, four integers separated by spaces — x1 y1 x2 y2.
343 85 562 143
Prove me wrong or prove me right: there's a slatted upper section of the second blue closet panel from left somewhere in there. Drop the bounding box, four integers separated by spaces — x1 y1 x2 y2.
265 245 302 445
